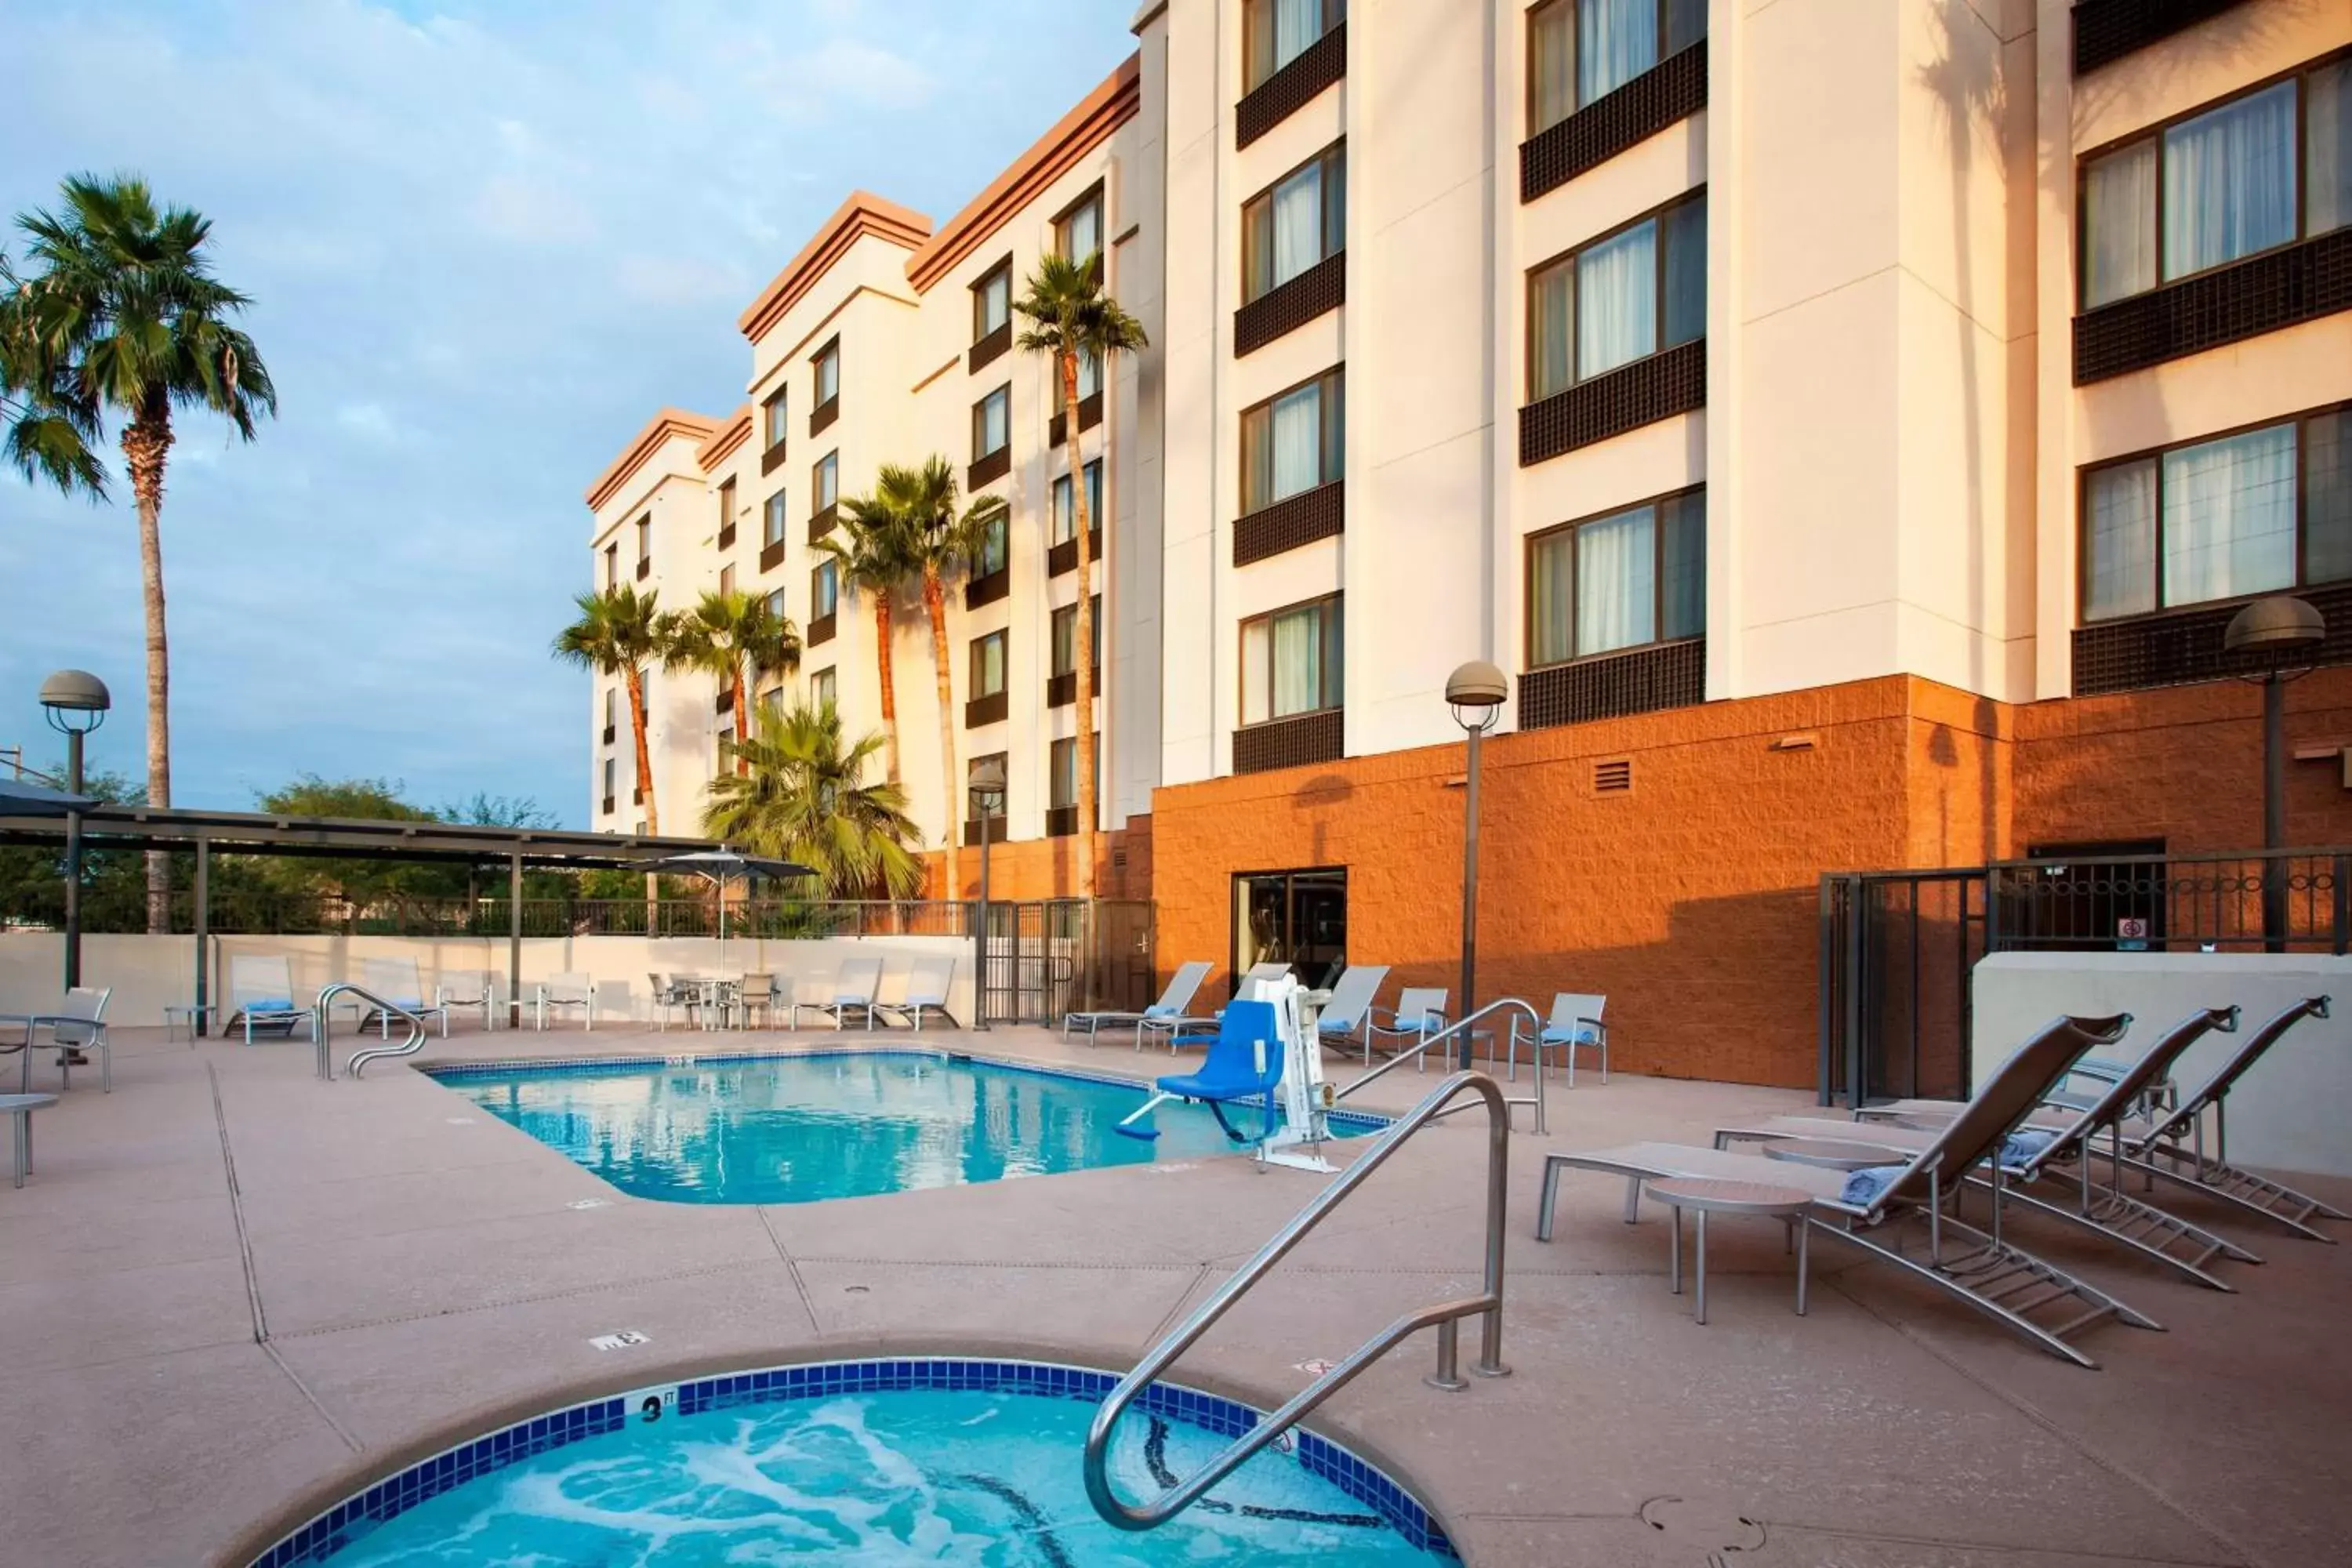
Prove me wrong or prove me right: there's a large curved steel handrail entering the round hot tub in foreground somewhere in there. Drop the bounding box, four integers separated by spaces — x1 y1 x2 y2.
1087 1072 1510 1530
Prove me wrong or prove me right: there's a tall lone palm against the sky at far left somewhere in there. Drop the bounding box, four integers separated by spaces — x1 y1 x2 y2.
0 174 278 931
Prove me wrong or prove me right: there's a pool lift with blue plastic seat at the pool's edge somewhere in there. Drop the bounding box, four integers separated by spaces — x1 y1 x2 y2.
1112 975 1338 1175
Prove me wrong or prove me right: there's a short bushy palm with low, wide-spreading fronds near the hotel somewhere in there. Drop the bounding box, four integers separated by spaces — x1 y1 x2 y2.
703 703 922 898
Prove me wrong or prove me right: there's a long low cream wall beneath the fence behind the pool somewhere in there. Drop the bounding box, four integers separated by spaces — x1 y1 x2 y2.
0 931 971 1027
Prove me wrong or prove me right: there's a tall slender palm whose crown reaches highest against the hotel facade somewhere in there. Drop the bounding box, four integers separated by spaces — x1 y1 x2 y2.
1014 252 1148 898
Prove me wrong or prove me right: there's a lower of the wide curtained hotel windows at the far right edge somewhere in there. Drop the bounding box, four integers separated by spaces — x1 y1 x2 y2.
2082 407 2352 621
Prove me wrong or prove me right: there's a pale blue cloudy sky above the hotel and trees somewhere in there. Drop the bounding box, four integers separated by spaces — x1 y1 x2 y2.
0 0 1134 825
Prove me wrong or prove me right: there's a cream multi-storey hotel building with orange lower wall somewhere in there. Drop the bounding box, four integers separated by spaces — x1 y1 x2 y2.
590 0 2352 1083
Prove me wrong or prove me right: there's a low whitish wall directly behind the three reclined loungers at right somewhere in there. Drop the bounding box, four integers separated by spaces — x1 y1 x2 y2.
1971 952 2352 1175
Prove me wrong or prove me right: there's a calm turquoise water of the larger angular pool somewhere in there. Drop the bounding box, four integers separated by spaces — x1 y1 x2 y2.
437 1051 1381 1203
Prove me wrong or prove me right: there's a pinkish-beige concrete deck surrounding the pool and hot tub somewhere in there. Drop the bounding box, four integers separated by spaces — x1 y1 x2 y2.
0 1027 2352 1568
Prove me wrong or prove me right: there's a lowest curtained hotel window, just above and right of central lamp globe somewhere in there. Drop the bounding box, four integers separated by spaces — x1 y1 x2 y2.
1526 489 1708 670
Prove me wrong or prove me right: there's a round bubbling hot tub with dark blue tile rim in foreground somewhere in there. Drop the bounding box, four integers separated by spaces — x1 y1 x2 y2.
254 1356 1454 1568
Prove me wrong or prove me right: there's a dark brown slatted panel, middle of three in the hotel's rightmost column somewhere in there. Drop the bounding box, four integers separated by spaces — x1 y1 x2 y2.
2074 228 2352 386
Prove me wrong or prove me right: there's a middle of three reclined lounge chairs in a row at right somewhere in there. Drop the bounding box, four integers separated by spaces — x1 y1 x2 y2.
1715 1006 2260 1290
